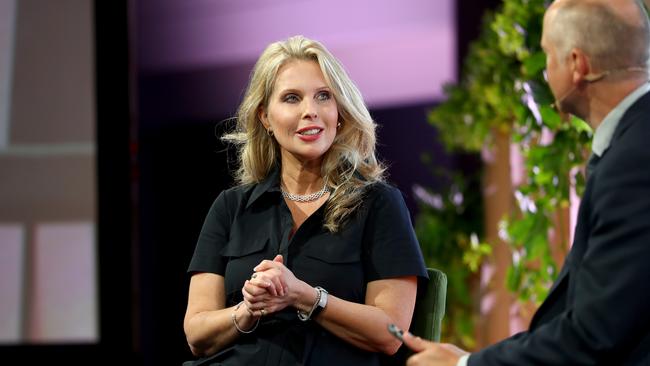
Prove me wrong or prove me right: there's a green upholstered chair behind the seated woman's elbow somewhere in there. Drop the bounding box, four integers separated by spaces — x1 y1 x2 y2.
381 268 447 366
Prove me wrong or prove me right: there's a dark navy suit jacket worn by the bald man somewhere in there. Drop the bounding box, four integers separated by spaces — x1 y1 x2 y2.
468 93 650 366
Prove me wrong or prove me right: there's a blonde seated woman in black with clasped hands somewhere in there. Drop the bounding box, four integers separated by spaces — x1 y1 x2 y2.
184 36 427 366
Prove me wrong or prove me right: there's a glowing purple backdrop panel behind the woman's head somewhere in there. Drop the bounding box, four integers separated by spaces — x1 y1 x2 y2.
136 0 456 108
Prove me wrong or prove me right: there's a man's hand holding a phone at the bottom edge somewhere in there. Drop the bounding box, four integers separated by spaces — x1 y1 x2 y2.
404 332 467 366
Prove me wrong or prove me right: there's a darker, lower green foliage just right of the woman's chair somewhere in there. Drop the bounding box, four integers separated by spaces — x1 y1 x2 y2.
413 162 492 349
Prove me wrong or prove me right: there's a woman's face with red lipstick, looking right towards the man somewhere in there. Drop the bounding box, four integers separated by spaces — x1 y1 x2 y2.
260 60 338 164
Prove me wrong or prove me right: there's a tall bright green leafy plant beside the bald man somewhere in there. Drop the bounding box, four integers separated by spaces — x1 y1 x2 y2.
416 0 592 328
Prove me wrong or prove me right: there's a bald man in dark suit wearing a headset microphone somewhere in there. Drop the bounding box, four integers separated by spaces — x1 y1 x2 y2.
404 0 650 366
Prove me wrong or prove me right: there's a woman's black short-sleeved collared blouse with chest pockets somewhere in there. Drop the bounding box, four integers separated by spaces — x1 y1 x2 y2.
188 169 427 366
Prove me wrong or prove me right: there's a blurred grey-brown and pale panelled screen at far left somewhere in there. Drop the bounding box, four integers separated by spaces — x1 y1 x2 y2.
0 0 98 344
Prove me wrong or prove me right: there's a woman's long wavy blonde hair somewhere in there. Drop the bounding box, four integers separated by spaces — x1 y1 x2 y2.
222 35 385 232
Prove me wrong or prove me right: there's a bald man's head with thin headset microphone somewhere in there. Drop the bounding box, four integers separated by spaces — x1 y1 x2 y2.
542 0 650 118
